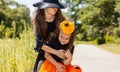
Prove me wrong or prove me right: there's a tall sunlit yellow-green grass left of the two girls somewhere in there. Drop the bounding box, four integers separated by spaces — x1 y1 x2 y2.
0 33 37 72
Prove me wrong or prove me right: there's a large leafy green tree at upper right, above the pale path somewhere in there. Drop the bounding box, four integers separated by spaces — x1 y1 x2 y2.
68 0 120 38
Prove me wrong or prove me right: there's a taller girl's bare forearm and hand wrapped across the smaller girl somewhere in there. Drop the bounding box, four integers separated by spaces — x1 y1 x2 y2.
41 45 66 60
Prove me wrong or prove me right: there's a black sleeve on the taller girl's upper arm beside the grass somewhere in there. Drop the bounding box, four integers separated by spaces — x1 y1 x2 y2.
34 34 44 52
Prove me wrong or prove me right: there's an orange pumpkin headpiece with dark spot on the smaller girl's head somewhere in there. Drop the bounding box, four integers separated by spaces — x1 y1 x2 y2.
60 21 75 34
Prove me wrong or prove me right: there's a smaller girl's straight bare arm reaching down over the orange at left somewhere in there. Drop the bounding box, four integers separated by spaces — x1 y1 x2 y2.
44 52 63 72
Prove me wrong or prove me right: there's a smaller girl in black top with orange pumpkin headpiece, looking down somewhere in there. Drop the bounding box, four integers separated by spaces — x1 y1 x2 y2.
39 21 82 72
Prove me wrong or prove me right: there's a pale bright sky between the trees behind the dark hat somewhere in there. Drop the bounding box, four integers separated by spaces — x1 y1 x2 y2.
14 0 67 17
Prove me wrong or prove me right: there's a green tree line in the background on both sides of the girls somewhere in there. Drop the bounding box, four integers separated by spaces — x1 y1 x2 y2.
0 0 120 43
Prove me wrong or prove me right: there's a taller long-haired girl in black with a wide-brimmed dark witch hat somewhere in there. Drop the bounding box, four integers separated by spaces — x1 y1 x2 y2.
32 0 67 72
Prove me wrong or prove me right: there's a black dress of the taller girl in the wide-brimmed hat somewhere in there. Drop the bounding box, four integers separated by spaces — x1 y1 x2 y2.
33 20 56 72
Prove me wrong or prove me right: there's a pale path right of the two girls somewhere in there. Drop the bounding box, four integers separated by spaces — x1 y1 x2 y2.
72 44 120 72
